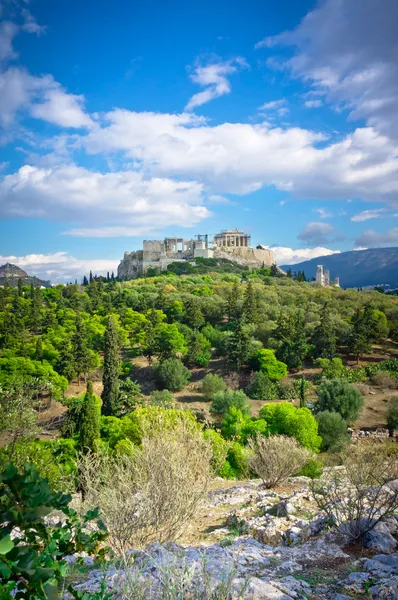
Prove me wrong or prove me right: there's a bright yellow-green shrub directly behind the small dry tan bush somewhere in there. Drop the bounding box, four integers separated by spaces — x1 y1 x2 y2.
260 402 322 452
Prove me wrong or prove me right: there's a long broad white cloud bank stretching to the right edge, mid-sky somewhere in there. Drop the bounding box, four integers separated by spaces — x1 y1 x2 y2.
81 109 398 200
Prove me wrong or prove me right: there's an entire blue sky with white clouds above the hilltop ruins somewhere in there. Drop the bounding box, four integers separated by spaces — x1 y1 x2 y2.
0 0 398 281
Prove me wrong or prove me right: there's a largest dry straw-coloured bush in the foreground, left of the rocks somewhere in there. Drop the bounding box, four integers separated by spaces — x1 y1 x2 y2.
80 420 212 552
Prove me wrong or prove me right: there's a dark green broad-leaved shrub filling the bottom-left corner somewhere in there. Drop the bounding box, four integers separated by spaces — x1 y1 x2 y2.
0 463 109 600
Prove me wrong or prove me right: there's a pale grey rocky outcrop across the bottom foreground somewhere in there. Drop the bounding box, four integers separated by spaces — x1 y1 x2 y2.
73 477 398 600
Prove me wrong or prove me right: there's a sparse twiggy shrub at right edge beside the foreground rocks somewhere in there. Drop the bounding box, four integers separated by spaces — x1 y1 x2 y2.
312 443 398 541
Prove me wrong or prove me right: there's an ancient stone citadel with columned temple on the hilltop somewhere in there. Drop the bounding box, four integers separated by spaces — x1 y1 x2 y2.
117 229 275 279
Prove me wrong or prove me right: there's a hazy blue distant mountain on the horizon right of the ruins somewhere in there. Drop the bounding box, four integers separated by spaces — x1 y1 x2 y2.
281 248 398 288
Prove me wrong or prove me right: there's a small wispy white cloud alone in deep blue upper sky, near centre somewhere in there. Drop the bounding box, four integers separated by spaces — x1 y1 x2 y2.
185 56 248 110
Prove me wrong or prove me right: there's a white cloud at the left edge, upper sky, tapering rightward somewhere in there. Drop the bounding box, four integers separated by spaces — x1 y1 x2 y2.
0 67 93 128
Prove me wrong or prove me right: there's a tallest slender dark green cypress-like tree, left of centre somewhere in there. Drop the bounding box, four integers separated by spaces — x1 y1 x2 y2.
102 317 120 416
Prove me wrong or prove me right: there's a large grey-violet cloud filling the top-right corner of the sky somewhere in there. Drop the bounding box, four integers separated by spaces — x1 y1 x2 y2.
257 0 398 138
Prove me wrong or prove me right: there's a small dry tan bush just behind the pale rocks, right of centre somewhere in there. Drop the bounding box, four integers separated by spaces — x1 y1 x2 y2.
249 435 310 488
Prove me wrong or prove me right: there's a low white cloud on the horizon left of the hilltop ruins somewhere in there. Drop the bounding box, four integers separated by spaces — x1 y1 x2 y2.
0 252 119 283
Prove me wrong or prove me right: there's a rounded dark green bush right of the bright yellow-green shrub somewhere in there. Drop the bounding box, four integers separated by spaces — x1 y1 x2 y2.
315 379 363 421
